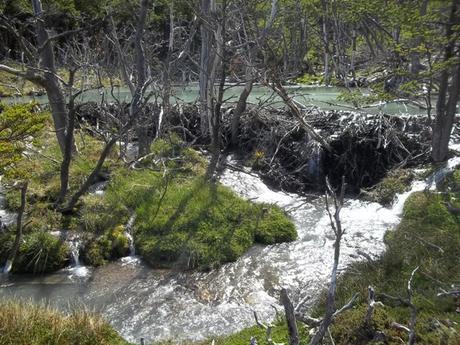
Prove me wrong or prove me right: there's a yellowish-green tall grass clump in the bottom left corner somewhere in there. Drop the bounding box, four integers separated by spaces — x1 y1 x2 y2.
0 300 129 345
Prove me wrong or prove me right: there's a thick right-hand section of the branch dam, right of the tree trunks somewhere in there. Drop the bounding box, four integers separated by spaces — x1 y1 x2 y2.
224 106 430 191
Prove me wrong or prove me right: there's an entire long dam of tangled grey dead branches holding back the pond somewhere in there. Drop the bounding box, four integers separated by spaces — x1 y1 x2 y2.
73 103 430 192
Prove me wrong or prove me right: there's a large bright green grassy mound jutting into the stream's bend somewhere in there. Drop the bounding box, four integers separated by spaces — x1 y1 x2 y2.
107 171 297 269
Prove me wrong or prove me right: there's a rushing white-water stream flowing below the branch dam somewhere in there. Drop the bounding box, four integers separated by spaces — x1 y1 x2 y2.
0 155 452 342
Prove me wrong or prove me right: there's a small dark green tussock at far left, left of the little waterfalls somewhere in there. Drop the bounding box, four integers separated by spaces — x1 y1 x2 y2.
12 231 70 273
